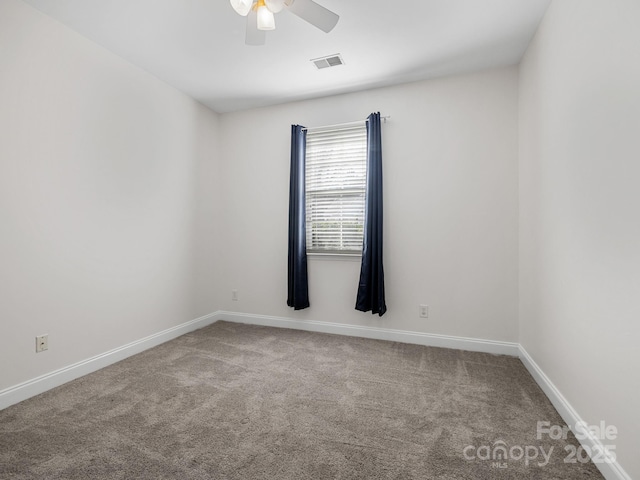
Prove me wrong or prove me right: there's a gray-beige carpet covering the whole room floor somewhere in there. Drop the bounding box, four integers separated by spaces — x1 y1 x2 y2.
0 322 602 480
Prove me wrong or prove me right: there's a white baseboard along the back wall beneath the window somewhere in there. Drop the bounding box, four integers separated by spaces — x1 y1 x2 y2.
216 311 519 357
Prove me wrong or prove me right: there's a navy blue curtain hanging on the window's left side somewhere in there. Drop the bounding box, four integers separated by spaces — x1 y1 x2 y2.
287 125 309 310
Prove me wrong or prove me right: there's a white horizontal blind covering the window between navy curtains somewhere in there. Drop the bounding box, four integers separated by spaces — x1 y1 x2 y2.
305 122 367 254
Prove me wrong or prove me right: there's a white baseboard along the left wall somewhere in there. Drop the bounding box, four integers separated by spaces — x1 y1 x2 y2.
0 314 216 410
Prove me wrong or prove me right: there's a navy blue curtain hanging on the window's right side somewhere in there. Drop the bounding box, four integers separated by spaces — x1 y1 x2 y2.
356 112 387 316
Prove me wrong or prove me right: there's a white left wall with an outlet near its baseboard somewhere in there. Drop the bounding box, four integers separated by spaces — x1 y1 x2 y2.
0 0 218 390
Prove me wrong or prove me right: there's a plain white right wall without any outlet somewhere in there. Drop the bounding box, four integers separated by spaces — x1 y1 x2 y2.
520 0 640 478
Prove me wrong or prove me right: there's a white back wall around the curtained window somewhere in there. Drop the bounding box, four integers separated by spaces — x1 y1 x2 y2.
220 68 518 341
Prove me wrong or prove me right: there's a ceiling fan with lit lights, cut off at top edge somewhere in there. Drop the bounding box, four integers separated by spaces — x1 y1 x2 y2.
230 0 340 45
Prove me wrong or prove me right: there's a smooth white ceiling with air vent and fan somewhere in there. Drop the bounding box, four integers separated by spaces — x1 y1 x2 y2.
24 0 551 112
